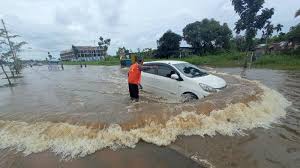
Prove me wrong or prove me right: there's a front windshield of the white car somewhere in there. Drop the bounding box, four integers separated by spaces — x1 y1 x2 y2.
174 63 208 78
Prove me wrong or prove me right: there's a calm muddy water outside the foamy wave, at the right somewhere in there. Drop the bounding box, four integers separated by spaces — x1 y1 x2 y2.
171 68 300 168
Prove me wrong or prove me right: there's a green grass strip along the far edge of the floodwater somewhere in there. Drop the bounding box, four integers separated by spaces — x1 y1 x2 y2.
64 52 300 70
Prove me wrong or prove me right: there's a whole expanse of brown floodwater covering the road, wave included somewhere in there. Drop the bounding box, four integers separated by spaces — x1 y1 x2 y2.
0 66 300 167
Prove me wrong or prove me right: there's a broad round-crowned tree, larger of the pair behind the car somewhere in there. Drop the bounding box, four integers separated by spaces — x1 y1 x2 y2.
183 19 232 54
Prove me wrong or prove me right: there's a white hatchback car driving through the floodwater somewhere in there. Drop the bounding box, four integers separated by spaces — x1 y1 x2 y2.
141 61 226 101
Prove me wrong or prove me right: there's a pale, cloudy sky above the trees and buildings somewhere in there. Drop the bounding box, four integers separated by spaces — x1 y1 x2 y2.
0 0 300 59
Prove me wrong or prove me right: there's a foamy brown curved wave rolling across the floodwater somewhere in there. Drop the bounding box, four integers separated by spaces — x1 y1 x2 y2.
0 83 290 159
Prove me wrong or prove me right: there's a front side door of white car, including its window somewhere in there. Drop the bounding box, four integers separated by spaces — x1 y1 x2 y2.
155 64 180 98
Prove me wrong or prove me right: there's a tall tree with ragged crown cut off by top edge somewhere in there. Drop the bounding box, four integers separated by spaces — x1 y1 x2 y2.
231 0 274 51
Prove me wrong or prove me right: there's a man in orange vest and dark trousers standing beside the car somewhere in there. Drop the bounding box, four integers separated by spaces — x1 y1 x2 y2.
128 57 143 101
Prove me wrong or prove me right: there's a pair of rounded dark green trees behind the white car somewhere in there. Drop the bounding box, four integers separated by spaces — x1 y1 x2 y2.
157 19 232 57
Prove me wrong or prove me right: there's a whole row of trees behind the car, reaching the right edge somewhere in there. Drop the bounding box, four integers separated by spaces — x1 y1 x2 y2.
155 0 300 58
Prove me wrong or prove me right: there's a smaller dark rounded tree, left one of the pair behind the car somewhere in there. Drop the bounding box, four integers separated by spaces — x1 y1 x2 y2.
157 30 182 58
